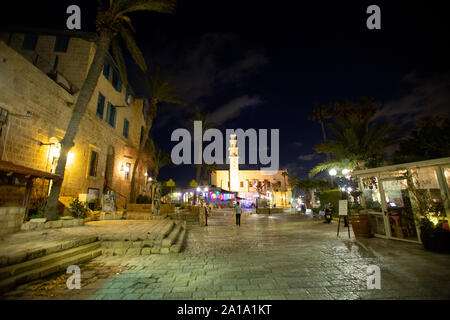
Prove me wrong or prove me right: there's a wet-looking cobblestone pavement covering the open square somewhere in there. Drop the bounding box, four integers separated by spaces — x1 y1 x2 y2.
3 213 450 300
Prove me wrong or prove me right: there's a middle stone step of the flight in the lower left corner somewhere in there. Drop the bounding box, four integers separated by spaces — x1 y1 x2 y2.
0 241 100 280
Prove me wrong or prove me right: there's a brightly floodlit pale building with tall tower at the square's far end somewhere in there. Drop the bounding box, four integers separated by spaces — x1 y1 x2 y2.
211 135 292 207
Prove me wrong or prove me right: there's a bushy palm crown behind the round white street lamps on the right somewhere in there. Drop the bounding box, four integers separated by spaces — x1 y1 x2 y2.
310 113 395 177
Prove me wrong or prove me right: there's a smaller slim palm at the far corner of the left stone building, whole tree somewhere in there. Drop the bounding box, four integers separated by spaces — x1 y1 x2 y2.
130 71 183 203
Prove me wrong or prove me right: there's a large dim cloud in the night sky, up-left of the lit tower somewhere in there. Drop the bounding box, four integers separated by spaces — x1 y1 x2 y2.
150 33 267 127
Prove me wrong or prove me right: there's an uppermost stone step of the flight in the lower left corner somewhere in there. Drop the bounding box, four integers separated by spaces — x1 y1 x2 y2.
0 236 98 268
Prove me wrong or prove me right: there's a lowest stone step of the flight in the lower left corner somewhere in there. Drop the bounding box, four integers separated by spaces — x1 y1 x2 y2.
0 243 102 292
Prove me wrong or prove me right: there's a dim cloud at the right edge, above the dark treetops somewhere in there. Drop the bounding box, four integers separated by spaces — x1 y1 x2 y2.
376 73 450 132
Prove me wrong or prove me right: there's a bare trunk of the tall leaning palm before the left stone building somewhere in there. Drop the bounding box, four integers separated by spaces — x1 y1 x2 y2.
45 33 111 220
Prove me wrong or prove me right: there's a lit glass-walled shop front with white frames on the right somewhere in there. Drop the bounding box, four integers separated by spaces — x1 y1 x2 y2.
352 158 450 242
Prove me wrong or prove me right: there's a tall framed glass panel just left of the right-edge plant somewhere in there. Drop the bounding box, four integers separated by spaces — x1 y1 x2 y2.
383 179 417 240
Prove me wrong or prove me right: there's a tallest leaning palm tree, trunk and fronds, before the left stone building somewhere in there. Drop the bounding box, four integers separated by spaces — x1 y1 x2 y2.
45 0 175 220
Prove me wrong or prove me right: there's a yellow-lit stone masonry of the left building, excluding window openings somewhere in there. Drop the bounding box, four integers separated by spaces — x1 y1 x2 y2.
0 37 147 207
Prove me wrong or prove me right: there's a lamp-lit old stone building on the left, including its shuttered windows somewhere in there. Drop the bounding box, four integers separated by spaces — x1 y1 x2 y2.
0 31 147 210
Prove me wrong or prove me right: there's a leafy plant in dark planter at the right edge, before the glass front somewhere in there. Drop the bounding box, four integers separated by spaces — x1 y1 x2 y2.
407 173 450 253
